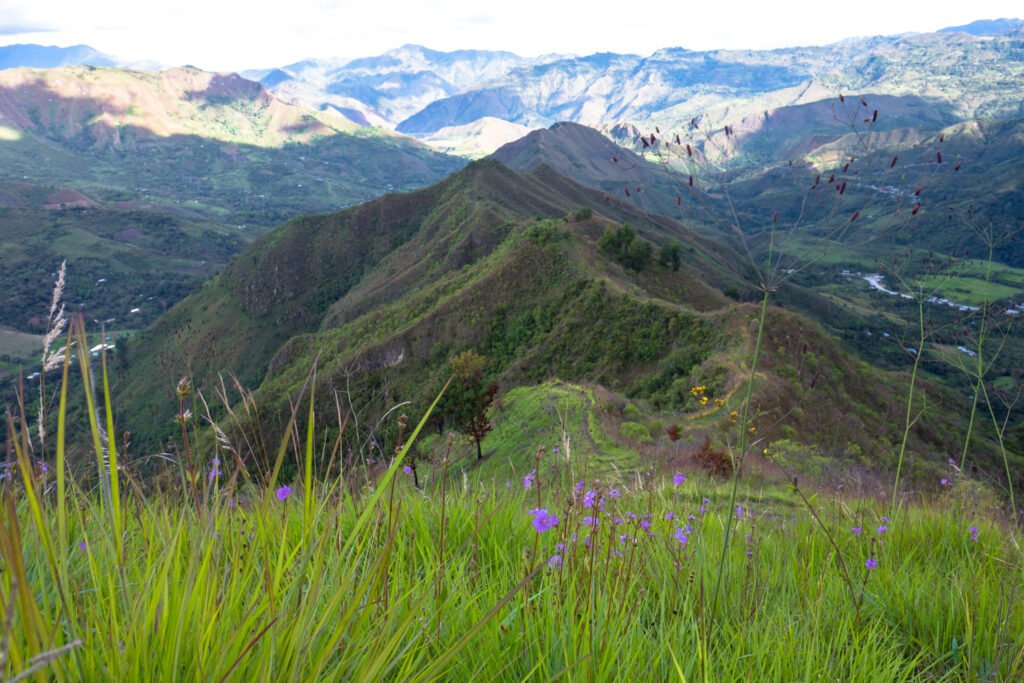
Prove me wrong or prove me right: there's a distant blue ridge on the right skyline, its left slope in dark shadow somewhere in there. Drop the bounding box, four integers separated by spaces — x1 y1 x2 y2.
397 34 1024 134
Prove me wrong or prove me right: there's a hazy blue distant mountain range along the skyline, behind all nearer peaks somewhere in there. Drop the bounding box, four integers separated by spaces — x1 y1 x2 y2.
235 26 1024 154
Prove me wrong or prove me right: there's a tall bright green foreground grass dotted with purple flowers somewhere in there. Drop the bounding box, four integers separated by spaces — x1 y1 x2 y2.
0 339 1024 681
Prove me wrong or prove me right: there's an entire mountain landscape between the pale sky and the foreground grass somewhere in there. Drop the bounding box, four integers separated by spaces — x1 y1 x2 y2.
0 20 1024 489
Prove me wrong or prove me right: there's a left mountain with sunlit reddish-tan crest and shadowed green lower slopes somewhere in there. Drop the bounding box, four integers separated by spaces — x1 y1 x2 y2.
0 67 464 332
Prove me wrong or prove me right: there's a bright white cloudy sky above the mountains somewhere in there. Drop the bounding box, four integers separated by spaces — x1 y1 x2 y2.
0 0 1024 71
